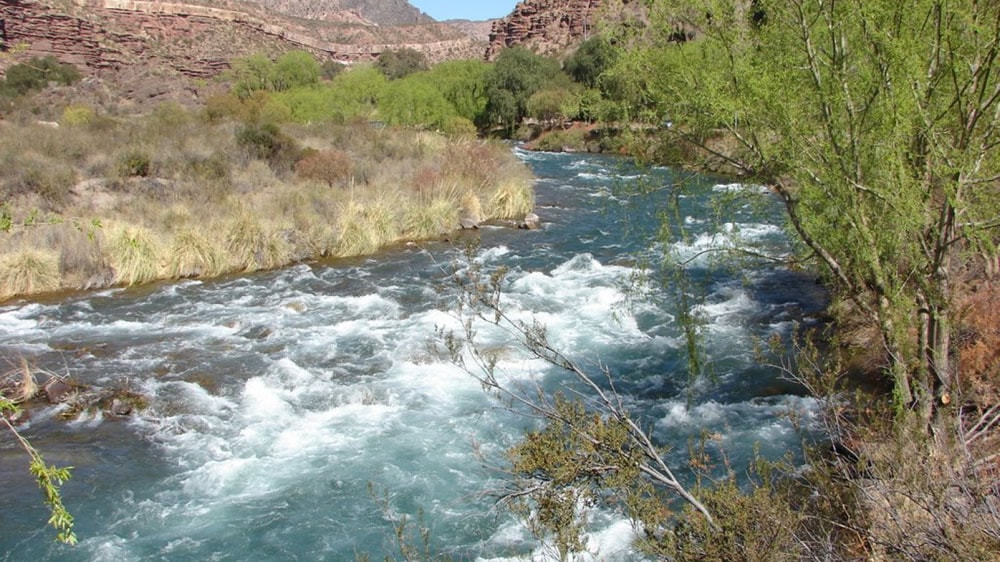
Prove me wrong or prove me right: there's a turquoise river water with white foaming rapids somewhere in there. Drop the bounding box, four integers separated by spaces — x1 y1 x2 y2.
0 147 825 561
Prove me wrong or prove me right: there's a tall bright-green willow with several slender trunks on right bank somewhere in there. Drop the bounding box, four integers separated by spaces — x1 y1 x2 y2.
633 0 1000 422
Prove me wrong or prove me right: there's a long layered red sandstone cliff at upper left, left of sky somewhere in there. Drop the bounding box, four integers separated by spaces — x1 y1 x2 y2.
0 0 483 78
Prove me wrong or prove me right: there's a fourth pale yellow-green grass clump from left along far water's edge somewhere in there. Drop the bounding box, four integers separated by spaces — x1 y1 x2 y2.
226 209 291 272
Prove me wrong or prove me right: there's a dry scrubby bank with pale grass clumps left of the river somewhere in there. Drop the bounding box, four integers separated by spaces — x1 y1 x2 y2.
0 109 533 300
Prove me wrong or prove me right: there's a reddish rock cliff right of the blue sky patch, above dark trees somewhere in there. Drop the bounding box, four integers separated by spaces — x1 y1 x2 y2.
486 0 641 60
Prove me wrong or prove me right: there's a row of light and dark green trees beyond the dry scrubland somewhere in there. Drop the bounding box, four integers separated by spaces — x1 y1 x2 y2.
216 42 620 137
